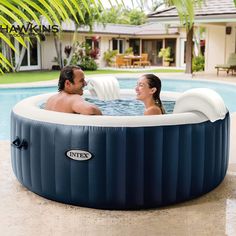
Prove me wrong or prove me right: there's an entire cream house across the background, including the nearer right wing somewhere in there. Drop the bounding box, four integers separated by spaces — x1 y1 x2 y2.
2 0 236 73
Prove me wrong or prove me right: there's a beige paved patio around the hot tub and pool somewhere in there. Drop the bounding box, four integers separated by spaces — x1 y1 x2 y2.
0 73 236 236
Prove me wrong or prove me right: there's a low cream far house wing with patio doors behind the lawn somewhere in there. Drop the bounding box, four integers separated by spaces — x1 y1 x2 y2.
9 22 180 70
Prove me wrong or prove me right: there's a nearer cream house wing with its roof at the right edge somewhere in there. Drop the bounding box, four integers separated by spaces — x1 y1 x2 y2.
149 0 236 73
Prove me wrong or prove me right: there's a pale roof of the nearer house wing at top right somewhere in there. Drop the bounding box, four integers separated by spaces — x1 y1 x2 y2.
148 0 236 22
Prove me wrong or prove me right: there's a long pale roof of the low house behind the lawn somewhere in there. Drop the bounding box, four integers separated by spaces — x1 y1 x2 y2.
62 21 178 36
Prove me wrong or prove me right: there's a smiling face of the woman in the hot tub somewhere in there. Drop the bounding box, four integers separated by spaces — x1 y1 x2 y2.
135 76 156 101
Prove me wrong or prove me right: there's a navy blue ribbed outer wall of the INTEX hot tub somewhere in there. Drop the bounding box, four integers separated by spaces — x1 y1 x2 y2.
11 113 229 209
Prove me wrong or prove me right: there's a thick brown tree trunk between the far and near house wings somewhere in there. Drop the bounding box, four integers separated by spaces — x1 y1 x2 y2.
185 26 193 74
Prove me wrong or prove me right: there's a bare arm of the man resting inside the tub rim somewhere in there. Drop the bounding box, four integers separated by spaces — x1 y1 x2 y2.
72 100 102 115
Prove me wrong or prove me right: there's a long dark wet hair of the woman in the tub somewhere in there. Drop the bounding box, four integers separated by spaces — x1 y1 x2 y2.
143 74 165 114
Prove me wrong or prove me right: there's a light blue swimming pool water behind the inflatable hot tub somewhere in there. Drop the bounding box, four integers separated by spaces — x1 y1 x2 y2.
0 79 236 140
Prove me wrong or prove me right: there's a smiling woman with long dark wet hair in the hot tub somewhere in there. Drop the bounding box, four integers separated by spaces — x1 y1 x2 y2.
135 74 165 115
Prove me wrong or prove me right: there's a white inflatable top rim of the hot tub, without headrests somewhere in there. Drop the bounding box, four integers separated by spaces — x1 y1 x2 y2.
13 90 218 127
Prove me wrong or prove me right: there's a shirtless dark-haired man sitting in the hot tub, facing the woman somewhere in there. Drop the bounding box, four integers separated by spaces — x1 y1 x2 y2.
45 66 102 115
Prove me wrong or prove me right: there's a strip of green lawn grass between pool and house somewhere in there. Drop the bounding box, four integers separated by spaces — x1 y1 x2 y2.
0 69 183 84
